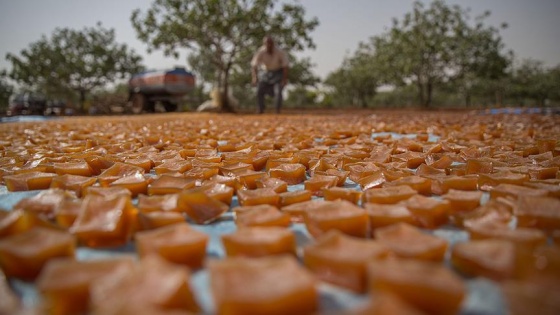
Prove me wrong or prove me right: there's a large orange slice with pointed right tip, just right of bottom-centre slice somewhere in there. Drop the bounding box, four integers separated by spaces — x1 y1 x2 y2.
303 230 390 293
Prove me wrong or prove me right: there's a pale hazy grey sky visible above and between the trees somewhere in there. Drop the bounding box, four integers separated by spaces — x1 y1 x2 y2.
0 0 560 78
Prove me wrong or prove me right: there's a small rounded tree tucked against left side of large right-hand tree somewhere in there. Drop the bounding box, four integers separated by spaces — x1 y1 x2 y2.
325 43 381 108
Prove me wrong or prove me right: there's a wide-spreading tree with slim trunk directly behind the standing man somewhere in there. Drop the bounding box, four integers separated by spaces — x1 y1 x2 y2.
131 0 319 111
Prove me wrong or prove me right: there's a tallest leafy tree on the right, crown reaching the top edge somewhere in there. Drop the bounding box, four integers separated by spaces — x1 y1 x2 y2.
372 0 508 107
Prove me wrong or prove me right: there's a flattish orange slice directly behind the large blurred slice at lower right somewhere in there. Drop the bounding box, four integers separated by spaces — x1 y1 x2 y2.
374 223 448 261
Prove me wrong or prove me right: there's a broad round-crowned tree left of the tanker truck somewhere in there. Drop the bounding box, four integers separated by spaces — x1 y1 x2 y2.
6 23 143 111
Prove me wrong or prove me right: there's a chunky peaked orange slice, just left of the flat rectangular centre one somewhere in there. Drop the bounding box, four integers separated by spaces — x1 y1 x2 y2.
134 223 209 269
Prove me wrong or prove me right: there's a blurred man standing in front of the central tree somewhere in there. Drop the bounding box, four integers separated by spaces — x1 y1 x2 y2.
251 36 288 114
